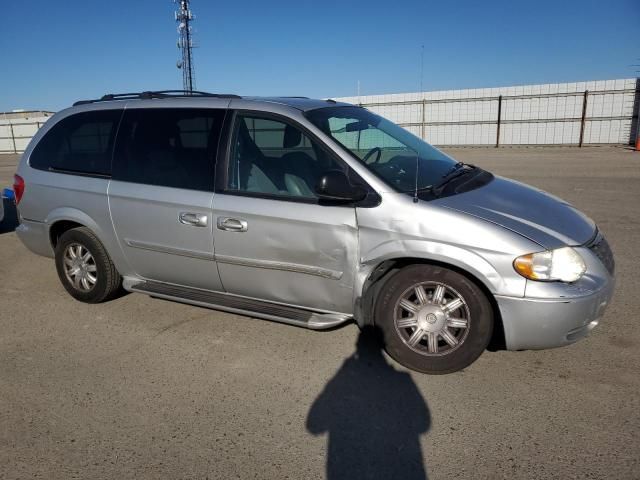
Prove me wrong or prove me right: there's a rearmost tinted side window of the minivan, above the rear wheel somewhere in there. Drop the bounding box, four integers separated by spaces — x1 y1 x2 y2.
29 110 122 175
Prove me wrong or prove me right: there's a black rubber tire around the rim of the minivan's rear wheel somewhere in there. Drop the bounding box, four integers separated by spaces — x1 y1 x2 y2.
55 227 122 303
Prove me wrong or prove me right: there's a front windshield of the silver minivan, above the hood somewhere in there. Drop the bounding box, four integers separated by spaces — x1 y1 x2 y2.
306 106 457 192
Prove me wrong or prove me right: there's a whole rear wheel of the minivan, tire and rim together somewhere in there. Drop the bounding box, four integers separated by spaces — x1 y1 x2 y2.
55 227 122 303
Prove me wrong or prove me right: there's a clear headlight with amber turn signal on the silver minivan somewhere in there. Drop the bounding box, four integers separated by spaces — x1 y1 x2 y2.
513 247 587 282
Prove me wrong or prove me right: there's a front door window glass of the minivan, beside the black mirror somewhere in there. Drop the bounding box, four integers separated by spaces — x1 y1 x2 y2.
226 115 344 199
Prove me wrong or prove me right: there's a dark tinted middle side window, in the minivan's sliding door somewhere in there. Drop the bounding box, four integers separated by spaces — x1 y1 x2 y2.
113 108 225 192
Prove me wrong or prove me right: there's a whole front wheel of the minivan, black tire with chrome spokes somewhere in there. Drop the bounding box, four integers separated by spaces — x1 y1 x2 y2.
374 264 494 374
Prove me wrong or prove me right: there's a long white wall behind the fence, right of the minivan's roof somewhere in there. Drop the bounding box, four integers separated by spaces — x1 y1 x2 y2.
336 78 640 145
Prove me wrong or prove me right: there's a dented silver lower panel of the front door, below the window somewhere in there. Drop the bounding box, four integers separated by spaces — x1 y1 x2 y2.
213 194 358 314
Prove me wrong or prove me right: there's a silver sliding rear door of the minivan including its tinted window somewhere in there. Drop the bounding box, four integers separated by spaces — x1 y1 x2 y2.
109 108 225 291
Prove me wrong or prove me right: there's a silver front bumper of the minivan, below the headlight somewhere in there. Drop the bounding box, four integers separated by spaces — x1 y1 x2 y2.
495 277 615 350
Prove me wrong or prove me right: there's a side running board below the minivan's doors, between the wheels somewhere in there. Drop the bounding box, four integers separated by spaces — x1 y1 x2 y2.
125 281 351 330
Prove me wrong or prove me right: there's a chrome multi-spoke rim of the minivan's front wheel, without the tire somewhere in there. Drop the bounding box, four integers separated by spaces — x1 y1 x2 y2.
394 282 471 356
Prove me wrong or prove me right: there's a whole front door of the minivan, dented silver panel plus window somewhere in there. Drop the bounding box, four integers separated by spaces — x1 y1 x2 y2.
213 113 358 313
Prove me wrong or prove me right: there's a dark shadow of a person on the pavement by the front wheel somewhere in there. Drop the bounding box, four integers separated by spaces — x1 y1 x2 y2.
306 327 431 480
